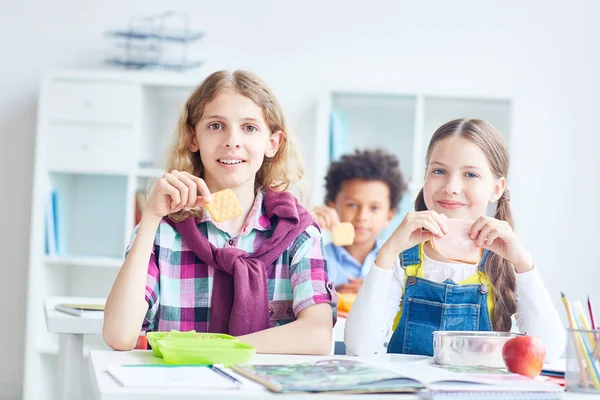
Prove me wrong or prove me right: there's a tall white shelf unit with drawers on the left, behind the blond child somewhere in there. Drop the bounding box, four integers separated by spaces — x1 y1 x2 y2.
23 71 204 400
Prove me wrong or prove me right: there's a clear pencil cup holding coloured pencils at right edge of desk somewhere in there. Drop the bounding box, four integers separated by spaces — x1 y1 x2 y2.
565 329 600 394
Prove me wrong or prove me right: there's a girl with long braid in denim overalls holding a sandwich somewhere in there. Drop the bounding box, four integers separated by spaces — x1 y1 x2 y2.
345 119 565 361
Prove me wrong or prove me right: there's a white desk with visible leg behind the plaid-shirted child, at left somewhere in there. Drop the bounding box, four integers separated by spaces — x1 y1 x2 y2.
44 297 106 400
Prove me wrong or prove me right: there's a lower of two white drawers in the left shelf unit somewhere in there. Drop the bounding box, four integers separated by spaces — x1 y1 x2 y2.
45 125 134 174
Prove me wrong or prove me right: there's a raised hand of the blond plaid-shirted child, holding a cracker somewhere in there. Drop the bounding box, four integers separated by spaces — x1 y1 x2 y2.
143 170 211 219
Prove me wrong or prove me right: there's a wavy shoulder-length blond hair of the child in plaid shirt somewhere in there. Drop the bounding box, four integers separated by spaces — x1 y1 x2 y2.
167 71 304 221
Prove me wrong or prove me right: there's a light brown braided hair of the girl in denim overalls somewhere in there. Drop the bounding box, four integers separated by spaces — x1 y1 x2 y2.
415 119 517 332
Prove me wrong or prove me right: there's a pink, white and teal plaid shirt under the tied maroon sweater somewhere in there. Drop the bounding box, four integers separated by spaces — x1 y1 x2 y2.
127 192 337 332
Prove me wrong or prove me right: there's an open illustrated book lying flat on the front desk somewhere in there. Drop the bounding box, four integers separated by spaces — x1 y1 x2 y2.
232 358 563 399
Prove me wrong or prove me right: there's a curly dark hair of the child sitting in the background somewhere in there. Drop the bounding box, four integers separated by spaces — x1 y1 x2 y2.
325 149 407 208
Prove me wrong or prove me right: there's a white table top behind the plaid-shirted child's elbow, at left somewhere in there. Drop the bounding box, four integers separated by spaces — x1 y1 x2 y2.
44 297 106 335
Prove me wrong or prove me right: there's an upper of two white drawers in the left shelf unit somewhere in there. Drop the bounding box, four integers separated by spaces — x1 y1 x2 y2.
46 81 139 124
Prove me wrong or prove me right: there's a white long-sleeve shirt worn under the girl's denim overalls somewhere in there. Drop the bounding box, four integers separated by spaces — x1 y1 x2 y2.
344 256 566 362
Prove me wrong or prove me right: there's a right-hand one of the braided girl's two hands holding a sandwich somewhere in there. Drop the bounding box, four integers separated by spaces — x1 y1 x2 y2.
471 216 533 273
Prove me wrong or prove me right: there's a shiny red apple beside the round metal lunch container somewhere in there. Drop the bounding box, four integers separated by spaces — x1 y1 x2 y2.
502 335 546 378
